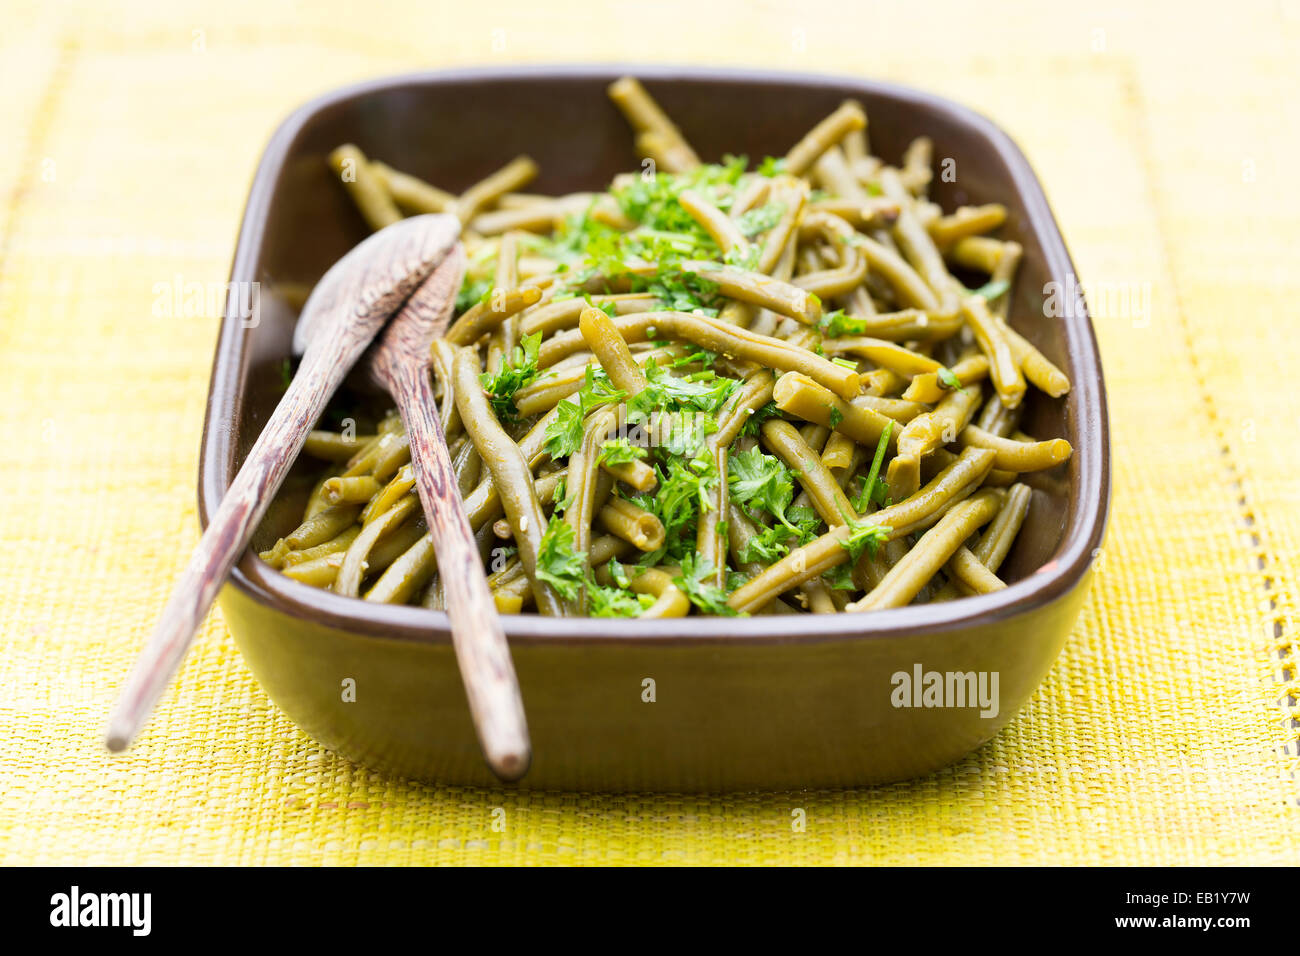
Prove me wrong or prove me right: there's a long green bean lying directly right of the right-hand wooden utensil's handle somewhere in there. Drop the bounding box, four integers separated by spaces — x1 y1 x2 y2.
455 349 564 615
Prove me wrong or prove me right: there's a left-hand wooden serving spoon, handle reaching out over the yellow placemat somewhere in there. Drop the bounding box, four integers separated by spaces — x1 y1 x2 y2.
104 216 460 750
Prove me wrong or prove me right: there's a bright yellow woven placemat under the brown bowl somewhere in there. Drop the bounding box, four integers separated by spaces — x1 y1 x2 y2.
0 0 1300 864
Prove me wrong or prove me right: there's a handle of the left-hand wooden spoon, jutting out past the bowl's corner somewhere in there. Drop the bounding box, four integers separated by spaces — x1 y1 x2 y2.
105 342 345 750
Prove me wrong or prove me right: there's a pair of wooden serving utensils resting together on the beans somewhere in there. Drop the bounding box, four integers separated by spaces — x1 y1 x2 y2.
105 216 530 780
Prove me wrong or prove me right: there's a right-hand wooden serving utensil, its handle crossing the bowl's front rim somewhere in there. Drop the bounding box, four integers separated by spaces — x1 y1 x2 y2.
365 243 532 780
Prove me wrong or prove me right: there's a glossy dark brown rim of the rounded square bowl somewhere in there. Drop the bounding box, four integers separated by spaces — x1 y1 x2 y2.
198 62 1110 645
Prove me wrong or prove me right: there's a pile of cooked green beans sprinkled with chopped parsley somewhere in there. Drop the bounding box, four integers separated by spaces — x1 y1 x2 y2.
269 78 1071 618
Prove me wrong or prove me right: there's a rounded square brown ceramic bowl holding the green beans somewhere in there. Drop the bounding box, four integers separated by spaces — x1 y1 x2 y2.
199 66 1109 790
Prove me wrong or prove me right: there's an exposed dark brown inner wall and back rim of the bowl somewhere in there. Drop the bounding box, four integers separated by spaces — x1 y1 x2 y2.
215 69 1106 634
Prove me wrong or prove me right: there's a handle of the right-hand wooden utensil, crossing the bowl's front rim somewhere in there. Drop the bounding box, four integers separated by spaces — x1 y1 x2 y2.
387 362 532 780
